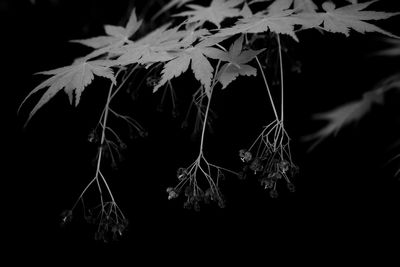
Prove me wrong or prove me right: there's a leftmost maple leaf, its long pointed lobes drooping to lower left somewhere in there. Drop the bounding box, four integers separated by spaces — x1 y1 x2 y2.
20 60 116 126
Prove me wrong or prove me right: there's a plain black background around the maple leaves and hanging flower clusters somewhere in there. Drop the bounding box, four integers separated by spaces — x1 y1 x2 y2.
7 0 400 262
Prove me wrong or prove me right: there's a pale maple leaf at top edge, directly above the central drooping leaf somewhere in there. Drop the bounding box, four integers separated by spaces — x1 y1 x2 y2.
174 0 243 28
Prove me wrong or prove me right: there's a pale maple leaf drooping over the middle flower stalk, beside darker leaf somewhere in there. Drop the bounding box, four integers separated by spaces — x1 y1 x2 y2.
153 36 227 96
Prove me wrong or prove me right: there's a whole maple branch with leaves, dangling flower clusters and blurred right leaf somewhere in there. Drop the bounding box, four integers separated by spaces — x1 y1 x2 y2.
21 0 399 242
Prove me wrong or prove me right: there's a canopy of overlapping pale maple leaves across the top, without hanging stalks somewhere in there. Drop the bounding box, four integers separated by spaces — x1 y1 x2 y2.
19 0 399 123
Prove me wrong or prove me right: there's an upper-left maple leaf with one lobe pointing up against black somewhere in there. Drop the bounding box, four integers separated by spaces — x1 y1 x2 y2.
71 9 142 49
